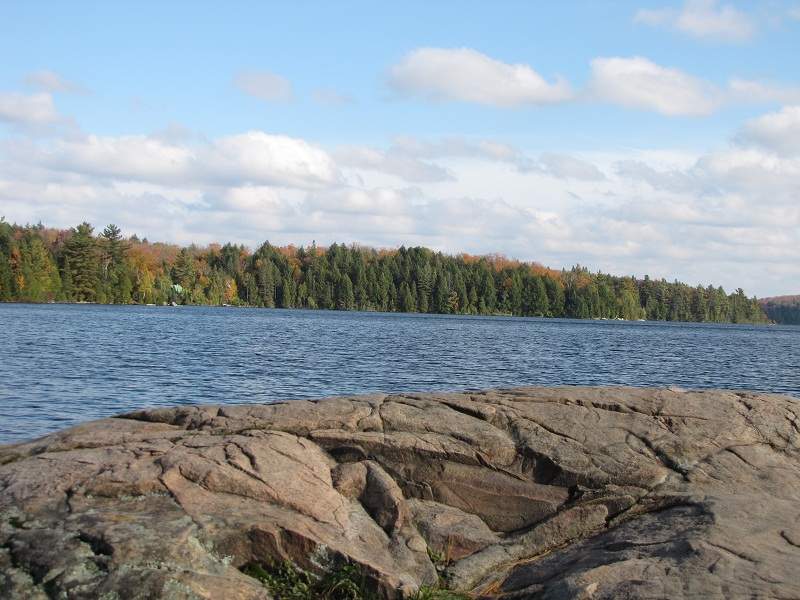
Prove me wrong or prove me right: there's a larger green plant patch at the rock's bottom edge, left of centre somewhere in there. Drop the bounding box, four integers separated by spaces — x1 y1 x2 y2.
242 561 375 600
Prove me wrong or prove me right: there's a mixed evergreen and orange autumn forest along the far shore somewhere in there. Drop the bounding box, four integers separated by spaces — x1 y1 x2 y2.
0 219 767 323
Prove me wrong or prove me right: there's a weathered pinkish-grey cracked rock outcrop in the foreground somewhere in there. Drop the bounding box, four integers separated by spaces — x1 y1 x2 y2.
0 388 800 599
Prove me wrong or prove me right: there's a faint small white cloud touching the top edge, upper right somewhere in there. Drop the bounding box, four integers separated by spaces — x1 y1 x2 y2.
634 0 756 42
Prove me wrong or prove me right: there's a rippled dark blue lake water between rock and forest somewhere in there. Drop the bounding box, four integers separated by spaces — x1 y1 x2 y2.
0 304 800 443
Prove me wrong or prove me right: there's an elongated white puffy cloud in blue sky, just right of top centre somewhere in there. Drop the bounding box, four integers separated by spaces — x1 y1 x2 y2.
389 48 572 107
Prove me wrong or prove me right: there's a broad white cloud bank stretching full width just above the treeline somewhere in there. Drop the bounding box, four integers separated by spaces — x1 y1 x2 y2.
0 113 800 295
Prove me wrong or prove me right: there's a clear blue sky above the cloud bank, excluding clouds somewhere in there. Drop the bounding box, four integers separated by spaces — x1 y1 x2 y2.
0 2 800 144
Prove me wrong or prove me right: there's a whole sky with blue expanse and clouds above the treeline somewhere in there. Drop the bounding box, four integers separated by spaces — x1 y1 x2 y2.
0 0 800 297
